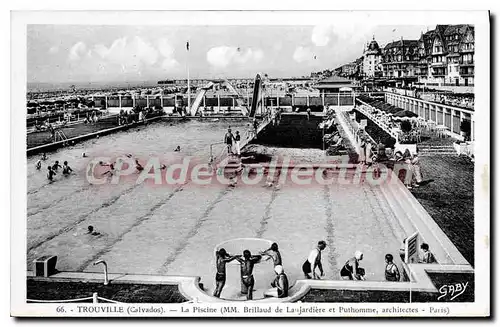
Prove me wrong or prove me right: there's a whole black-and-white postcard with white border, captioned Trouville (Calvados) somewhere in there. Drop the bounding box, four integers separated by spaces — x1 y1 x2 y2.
11 11 490 318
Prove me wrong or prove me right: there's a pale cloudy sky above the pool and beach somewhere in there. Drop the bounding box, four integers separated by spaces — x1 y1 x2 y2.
27 24 434 83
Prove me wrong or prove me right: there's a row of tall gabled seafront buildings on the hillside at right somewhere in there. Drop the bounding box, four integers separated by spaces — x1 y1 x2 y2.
335 25 474 86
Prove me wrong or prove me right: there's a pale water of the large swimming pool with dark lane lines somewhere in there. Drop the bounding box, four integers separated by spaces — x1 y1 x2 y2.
27 121 404 299
